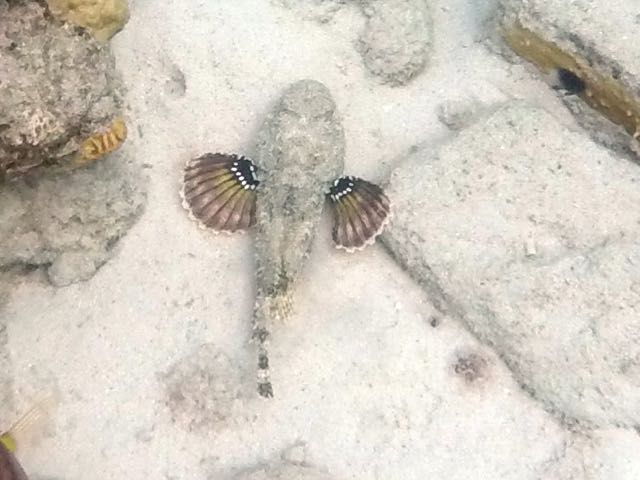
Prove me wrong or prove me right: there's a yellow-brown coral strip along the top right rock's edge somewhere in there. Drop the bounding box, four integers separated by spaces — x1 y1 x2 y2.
503 23 640 138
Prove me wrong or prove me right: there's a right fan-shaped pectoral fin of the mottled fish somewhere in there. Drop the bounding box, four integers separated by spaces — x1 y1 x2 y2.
327 177 391 252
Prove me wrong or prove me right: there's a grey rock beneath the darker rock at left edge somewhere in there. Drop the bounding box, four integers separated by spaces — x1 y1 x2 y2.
0 156 145 286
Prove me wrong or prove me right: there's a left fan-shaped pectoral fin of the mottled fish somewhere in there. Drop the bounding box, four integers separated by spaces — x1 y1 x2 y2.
180 153 260 233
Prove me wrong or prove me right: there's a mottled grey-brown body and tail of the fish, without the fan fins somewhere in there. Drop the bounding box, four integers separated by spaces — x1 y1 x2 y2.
253 80 345 397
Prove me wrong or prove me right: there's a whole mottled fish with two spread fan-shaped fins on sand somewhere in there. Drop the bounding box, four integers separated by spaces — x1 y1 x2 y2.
180 80 391 398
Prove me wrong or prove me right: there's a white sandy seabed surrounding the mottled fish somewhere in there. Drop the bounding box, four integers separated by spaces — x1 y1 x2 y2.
2 0 596 480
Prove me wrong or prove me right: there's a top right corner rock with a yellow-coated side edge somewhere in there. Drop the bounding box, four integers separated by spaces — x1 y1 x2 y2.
499 0 640 157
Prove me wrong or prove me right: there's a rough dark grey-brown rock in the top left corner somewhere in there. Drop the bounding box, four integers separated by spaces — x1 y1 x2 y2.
0 1 122 181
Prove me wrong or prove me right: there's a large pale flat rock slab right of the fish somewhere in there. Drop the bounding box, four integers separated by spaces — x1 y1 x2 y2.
382 104 640 426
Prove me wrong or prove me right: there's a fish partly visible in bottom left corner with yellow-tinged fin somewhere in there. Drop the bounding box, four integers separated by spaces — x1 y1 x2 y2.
0 394 56 480
